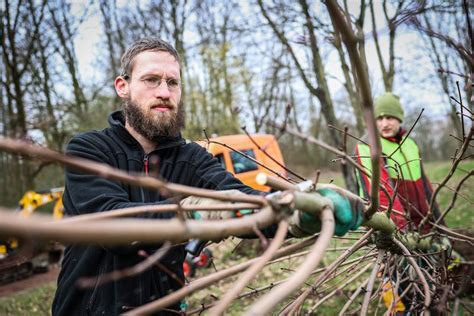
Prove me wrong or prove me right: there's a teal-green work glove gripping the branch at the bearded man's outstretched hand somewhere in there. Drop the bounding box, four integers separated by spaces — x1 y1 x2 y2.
289 188 364 237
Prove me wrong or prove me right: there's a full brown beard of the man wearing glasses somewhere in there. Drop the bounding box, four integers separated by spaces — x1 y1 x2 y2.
124 99 185 141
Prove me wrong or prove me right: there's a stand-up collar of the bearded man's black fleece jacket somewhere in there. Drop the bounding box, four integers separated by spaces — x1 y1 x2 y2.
108 110 186 150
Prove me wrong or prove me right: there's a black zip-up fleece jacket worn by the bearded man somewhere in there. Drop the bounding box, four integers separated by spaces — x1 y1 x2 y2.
52 111 271 315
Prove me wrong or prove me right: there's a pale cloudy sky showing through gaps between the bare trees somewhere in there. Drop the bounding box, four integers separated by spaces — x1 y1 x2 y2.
73 0 460 123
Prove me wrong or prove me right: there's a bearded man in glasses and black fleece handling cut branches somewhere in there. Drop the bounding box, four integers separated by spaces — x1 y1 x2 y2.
52 38 361 315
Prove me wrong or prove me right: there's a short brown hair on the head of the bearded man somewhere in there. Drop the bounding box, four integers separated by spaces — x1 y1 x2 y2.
120 37 181 77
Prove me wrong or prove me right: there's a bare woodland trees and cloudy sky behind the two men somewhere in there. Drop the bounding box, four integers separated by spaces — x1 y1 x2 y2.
0 0 474 206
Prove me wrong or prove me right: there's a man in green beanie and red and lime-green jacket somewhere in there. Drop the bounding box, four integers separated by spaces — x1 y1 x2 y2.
356 93 439 231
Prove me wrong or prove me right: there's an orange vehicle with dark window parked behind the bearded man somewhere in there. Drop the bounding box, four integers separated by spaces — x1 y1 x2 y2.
197 134 286 192
